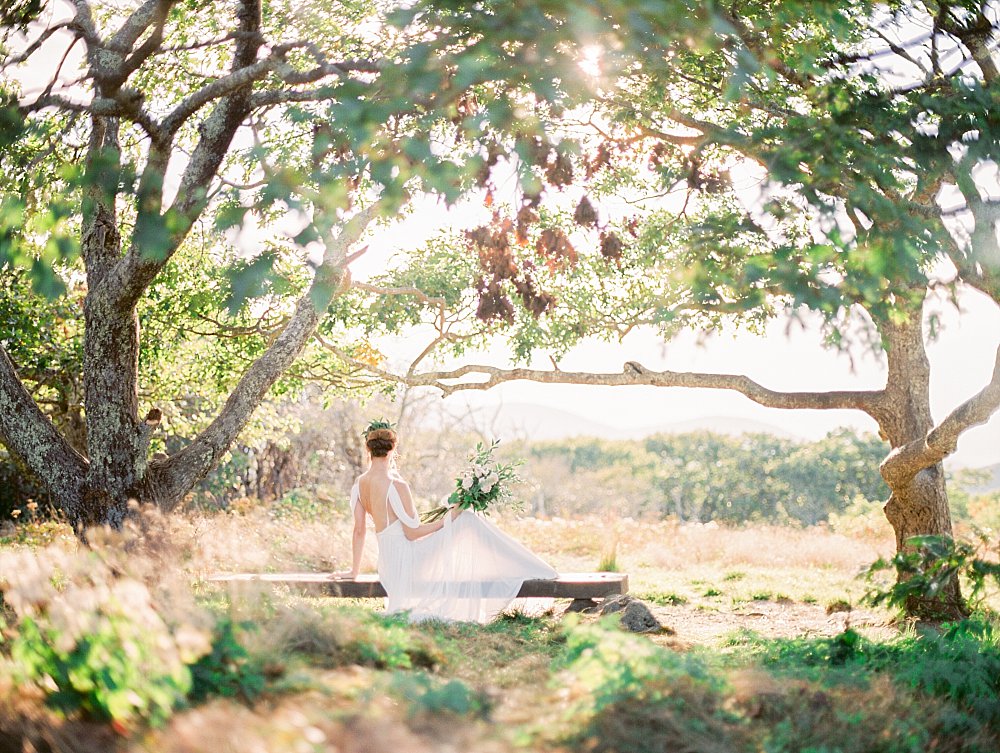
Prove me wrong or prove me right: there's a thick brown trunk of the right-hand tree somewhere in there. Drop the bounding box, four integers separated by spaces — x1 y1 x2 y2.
877 307 966 620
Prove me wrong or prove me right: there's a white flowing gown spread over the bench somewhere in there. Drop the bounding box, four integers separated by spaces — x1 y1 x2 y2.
351 481 557 623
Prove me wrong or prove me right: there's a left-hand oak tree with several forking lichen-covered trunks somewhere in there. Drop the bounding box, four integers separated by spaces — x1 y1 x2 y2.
0 0 588 526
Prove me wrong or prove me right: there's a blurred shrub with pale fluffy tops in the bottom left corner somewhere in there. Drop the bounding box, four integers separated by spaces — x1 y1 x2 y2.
0 548 208 728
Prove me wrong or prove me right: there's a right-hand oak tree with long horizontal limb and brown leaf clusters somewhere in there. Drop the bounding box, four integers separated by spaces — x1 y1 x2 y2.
345 0 1000 614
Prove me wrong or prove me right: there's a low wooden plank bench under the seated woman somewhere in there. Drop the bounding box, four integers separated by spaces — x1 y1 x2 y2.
208 573 628 612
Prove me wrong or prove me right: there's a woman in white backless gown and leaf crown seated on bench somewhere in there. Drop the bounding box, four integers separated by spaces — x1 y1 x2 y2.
338 428 556 622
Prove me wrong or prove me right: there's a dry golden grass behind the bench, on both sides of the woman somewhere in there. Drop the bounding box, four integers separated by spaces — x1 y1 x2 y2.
0 500 893 641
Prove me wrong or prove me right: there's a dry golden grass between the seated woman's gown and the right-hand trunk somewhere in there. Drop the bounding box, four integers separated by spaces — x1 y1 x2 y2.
502 516 893 610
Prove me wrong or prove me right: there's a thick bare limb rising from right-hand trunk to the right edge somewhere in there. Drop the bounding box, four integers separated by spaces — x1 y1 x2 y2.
879 349 1000 488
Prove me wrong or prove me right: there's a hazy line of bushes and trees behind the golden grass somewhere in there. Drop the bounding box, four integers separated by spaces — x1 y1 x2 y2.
0 414 888 525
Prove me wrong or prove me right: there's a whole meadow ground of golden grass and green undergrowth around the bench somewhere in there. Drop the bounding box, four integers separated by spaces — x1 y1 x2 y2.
0 496 1000 753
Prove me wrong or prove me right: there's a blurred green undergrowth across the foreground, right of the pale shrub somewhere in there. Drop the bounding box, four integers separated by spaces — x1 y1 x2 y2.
7 560 1000 753
